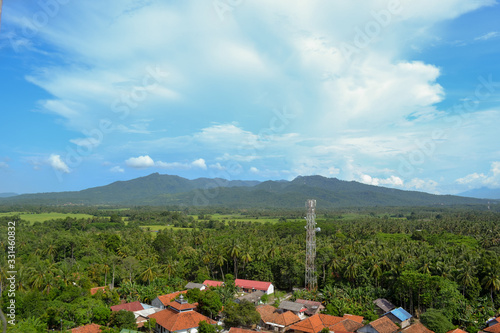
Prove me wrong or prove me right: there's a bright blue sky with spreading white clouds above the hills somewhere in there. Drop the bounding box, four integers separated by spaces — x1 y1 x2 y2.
0 0 500 194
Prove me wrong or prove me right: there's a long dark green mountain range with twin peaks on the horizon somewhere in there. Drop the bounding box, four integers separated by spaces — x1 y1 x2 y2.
0 173 487 208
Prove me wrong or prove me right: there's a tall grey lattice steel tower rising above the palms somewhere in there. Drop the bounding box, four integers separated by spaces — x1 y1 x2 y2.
306 199 320 290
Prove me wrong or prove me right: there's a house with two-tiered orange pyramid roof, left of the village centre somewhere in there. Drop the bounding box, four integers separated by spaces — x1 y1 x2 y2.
149 294 216 333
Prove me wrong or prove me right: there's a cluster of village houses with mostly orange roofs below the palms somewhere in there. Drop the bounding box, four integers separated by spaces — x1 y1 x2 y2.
72 279 500 333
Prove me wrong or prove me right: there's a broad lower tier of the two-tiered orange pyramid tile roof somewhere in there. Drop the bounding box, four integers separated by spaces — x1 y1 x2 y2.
149 309 216 332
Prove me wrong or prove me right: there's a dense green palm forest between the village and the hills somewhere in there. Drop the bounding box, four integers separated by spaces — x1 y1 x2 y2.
0 207 500 333
